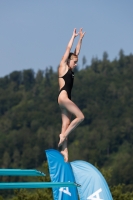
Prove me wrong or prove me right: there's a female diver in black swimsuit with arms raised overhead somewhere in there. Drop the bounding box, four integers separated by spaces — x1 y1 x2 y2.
58 28 85 162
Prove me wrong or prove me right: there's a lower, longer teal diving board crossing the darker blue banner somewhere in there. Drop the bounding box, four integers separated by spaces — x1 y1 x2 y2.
0 182 80 189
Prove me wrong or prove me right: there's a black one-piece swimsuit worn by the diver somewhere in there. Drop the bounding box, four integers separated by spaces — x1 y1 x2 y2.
58 69 74 99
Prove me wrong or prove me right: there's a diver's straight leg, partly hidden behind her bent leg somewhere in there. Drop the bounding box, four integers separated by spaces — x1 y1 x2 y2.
61 108 71 162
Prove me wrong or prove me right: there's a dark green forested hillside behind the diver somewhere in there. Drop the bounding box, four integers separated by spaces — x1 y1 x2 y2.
0 49 133 200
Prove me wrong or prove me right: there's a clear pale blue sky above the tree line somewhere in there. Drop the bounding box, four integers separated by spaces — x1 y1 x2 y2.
0 0 133 77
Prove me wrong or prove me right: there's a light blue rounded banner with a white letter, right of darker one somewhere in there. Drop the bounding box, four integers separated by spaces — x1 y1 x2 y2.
71 161 113 200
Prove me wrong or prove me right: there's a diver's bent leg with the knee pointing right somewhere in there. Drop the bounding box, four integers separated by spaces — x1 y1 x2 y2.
58 98 84 147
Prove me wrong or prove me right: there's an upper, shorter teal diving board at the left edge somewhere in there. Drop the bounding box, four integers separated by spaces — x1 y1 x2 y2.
0 169 45 176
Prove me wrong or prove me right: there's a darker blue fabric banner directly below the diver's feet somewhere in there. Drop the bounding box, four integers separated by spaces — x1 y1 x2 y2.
46 149 78 200
